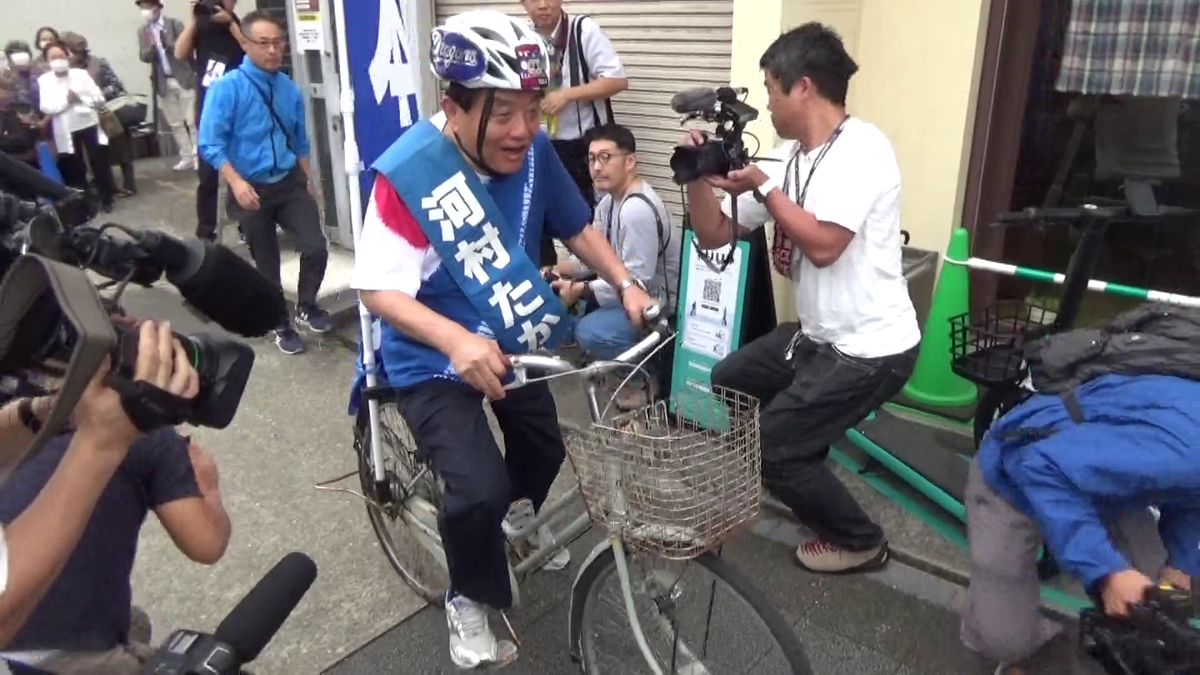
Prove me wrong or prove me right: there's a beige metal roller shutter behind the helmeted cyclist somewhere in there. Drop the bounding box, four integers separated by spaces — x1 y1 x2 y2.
436 0 733 219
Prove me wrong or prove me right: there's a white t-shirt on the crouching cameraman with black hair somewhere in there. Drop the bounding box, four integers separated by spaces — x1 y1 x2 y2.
721 118 920 358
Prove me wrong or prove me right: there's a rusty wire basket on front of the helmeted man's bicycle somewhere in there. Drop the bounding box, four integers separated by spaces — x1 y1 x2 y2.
566 387 762 560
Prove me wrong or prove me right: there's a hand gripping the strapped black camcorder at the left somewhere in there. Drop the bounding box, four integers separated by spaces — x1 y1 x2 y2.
72 321 200 449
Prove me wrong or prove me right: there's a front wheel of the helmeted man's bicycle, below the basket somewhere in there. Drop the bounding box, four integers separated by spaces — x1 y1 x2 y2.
571 548 812 675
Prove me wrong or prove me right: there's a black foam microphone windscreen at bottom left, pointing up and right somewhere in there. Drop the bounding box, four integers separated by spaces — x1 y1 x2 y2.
214 552 317 664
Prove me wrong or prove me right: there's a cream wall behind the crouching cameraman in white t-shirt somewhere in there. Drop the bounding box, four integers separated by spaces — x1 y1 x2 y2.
731 0 986 321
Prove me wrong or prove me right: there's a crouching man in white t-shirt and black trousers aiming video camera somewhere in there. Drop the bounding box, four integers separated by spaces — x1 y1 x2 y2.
684 23 920 573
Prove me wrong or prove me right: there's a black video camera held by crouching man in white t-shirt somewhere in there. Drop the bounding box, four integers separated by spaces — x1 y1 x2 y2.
671 86 758 185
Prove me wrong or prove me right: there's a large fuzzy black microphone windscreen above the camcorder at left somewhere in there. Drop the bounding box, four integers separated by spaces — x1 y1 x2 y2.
137 232 288 338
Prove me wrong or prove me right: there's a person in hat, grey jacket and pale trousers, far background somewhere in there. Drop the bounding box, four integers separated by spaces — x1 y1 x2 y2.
137 0 197 171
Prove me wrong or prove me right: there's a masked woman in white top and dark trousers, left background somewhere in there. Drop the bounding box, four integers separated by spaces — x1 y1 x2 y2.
37 43 116 213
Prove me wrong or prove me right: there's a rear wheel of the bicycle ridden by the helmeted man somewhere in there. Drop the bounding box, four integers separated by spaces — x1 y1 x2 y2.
354 401 450 607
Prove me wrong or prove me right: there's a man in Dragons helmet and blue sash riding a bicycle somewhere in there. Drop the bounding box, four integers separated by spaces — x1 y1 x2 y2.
352 11 653 668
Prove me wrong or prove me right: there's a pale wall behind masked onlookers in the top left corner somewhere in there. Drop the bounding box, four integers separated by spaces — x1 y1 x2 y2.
0 0 196 94
